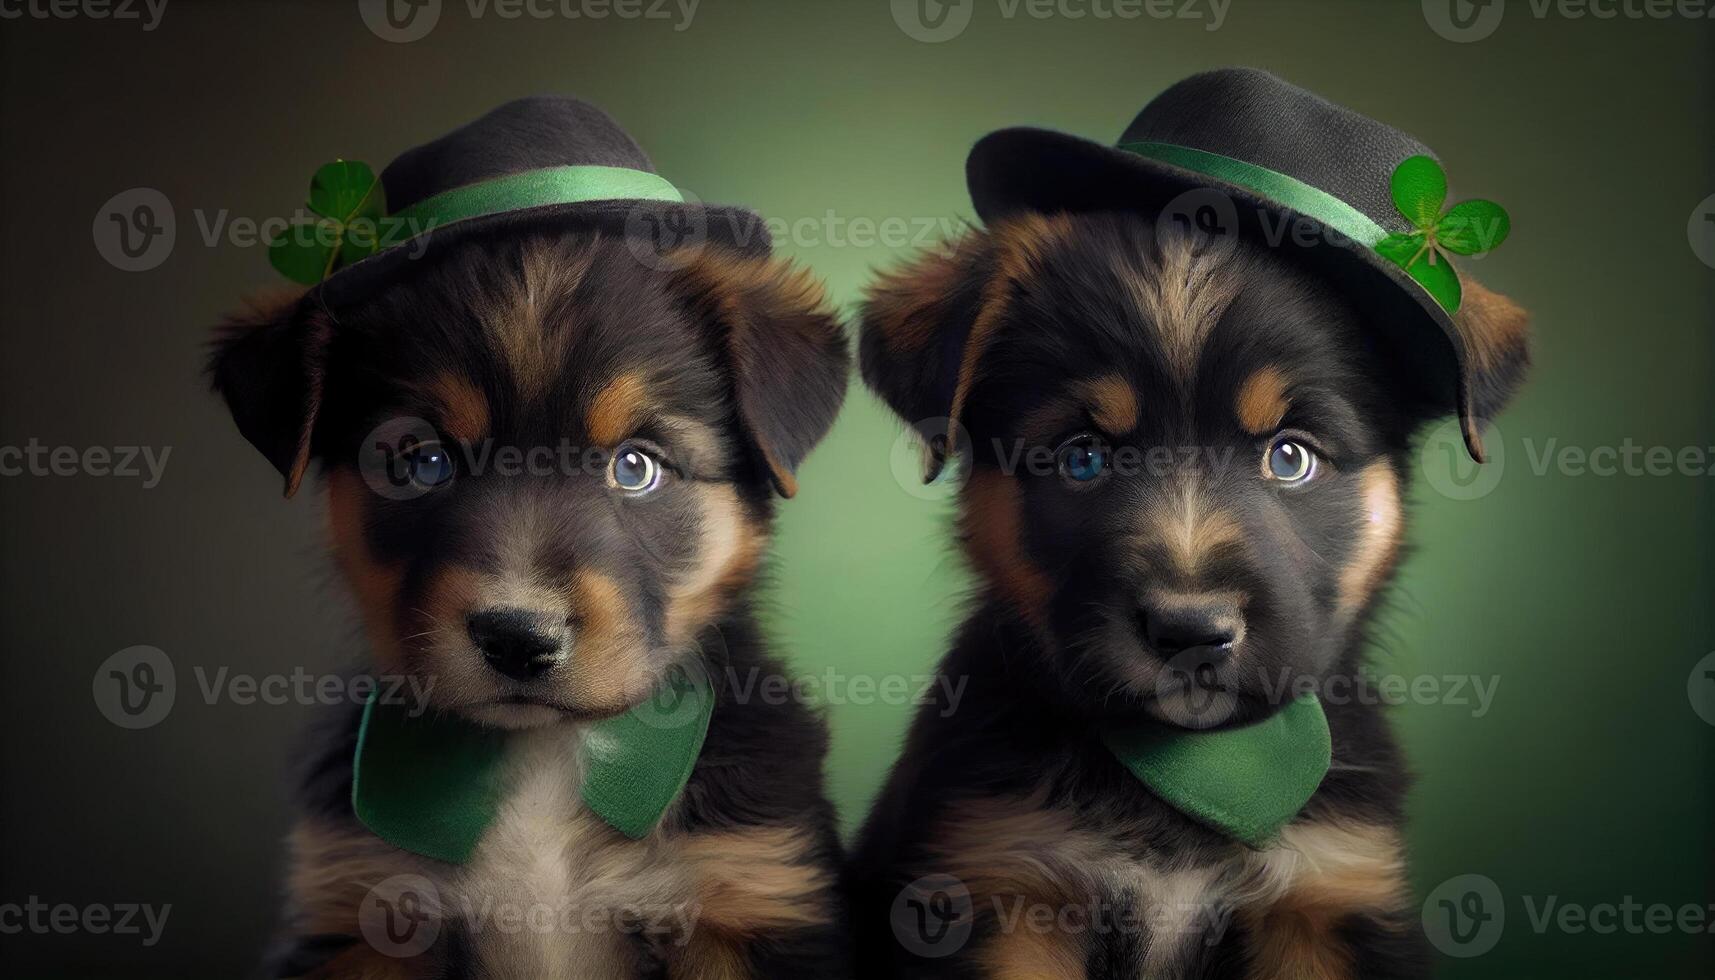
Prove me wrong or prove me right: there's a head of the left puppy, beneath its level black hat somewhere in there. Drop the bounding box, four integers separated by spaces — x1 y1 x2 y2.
214 239 845 726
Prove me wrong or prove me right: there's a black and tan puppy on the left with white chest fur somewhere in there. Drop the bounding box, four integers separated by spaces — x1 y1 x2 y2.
209 227 849 980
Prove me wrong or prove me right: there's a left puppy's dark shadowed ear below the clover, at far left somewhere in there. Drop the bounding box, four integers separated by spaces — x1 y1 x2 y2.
208 293 331 498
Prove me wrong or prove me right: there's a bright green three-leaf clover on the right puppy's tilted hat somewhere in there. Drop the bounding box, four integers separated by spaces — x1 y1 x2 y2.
1375 156 1513 312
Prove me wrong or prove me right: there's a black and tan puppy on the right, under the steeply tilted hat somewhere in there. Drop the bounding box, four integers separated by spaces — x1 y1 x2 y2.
852 209 1526 980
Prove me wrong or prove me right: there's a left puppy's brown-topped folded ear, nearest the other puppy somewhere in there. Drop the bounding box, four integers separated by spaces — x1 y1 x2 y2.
674 249 851 498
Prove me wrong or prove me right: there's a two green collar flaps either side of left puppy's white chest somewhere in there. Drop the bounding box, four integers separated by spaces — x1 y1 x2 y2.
352 671 715 863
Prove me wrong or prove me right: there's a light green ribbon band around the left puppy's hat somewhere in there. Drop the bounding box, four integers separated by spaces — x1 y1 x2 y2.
388 166 684 237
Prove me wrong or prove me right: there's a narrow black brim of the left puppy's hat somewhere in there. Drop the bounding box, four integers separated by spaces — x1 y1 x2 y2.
305 199 773 307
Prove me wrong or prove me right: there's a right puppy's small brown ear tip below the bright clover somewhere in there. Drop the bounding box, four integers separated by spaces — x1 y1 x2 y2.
1453 276 1530 462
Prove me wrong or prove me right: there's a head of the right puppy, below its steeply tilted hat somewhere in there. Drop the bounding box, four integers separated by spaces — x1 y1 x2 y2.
863 215 1523 728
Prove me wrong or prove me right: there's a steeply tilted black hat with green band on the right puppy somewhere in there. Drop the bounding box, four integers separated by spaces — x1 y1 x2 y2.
966 69 1497 460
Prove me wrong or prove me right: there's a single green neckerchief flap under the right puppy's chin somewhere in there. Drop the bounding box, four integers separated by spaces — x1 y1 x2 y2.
1104 693 1333 848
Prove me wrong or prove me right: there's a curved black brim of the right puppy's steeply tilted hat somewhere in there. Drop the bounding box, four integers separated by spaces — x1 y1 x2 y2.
966 127 1483 460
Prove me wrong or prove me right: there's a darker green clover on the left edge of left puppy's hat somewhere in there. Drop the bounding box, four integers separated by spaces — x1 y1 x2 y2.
268 160 386 285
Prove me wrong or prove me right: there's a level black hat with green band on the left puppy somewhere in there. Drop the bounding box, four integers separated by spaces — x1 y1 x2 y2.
296 96 770 305
